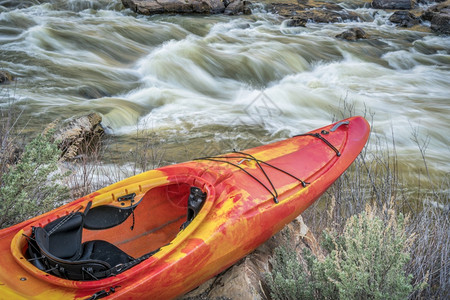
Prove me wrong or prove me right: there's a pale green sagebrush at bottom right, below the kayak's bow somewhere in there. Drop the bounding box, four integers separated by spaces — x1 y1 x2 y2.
267 208 423 299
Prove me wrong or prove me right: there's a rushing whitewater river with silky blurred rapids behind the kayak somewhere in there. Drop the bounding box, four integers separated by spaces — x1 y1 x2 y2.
0 0 450 189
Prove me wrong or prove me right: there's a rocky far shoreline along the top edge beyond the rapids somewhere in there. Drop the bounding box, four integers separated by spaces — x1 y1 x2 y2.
122 0 450 34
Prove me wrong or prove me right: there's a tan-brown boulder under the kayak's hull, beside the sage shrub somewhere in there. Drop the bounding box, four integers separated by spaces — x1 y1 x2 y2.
180 216 324 300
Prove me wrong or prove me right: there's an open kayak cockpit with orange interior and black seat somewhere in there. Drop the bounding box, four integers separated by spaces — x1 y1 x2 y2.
13 176 213 281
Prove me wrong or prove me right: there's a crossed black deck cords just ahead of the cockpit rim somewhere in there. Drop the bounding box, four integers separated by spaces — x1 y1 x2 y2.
194 150 309 203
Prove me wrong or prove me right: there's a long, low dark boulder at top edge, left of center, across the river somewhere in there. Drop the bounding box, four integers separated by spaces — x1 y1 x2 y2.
122 0 251 15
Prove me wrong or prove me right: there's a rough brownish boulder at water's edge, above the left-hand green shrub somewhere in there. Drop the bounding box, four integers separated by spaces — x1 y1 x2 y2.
49 113 104 161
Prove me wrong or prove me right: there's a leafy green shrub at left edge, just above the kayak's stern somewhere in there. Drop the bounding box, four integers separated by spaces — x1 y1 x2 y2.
0 135 69 228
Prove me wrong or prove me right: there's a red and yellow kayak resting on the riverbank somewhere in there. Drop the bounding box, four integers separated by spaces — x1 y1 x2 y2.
0 117 370 299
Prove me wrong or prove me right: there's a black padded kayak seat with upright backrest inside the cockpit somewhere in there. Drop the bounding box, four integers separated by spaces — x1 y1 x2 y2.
28 212 135 280
